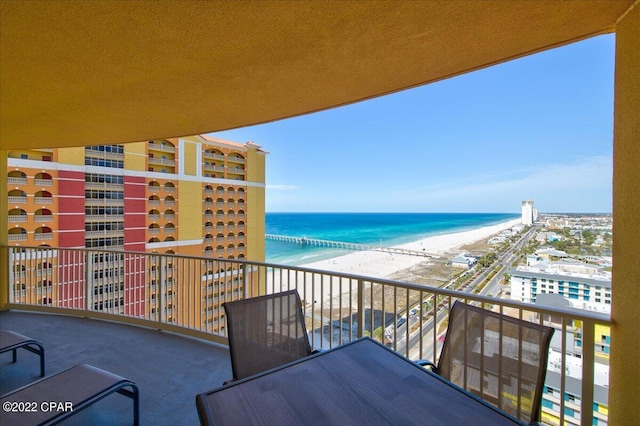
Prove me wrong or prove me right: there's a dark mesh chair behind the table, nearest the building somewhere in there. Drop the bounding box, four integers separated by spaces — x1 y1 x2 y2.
222 290 312 383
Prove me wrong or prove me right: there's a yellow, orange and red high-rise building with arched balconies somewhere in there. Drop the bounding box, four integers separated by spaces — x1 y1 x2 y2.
7 135 267 332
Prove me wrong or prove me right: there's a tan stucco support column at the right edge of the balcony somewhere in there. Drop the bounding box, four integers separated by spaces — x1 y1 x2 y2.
609 2 640 425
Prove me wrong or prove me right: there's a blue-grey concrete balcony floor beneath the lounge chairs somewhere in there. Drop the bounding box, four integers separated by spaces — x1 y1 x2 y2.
0 311 231 426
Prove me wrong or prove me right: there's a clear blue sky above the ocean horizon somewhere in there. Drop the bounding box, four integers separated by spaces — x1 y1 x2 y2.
212 35 615 213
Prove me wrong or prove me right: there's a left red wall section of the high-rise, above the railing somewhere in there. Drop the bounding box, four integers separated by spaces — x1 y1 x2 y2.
58 170 84 248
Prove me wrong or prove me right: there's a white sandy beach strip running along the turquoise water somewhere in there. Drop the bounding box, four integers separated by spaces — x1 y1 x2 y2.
301 219 520 278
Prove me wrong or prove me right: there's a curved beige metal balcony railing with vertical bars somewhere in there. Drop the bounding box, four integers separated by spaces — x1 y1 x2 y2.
2 247 611 425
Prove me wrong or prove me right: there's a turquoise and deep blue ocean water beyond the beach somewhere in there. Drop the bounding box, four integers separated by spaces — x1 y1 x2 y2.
266 213 520 265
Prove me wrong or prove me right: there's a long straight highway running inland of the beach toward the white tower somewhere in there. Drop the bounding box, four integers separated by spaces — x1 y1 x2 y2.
392 225 538 360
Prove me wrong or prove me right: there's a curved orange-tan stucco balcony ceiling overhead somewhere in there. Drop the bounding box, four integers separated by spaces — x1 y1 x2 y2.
0 0 633 150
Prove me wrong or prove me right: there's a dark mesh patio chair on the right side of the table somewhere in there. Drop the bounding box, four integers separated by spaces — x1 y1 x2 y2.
418 301 553 423
